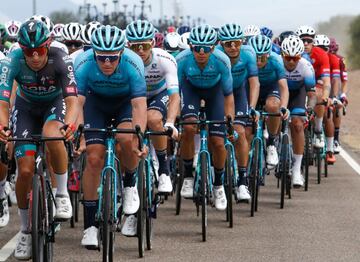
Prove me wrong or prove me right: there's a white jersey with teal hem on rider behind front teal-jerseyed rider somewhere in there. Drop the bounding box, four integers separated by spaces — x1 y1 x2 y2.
145 48 179 98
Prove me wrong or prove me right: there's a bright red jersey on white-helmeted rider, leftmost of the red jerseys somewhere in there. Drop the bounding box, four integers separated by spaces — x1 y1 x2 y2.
310 46 330 80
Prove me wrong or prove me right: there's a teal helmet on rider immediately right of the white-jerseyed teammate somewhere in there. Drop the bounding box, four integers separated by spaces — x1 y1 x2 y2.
189 24 217 45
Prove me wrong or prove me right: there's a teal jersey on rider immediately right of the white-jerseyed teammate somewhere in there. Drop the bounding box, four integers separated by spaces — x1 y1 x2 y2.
176 49 233 96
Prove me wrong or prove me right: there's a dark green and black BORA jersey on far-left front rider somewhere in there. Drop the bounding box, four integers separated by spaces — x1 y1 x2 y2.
0 47 77 103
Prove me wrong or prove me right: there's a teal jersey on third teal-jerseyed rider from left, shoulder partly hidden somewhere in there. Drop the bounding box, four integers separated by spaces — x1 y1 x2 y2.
216 45 258 90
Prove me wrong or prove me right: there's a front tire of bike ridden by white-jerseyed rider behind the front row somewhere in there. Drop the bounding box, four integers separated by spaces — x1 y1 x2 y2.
137 159 146 257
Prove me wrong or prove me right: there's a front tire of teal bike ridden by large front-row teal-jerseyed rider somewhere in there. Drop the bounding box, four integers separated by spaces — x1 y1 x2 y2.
102 170 113 262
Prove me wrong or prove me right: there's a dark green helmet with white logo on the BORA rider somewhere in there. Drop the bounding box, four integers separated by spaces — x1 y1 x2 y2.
18 20 50 48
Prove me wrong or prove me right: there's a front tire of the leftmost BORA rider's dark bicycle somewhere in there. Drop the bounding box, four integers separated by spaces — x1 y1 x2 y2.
31 174 45 262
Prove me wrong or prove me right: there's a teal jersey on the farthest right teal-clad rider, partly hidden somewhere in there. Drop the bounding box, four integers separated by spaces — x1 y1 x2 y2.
259 52 286 86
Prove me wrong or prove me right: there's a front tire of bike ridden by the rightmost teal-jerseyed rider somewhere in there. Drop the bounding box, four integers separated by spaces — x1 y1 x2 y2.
249 139 260 217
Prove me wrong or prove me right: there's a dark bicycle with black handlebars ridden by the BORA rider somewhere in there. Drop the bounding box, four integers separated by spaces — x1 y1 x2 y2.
1 135 72 262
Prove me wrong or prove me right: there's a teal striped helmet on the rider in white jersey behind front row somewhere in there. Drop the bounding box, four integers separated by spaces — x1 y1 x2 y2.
126 20 155 41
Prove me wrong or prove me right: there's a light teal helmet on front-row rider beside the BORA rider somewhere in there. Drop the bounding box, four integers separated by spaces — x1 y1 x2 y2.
91 25 125 51
